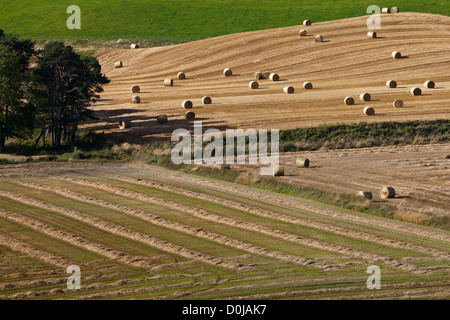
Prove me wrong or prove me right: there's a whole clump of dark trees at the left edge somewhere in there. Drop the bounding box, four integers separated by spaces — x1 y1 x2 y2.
0 29 110 153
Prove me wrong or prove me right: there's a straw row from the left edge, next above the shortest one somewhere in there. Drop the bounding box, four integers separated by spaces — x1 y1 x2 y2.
0 209 155 269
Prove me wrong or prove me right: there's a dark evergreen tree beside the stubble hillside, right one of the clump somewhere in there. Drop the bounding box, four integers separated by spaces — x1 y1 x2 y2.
31 42 109 148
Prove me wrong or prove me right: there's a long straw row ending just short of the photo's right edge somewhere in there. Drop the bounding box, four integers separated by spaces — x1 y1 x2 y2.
55 178 425 272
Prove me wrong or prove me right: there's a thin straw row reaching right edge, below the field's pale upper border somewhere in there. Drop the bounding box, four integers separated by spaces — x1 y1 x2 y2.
110 177 450 258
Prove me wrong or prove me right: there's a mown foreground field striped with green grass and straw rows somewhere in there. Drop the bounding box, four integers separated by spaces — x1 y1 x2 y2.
0 162 450 299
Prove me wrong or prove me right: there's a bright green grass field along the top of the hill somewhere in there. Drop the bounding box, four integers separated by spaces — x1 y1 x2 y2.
0 0 450 43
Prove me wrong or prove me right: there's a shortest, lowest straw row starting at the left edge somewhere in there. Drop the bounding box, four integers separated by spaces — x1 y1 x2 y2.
0 234 73 269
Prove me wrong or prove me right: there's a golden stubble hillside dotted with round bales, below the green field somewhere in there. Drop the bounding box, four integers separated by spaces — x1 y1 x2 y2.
90 13 450 142
